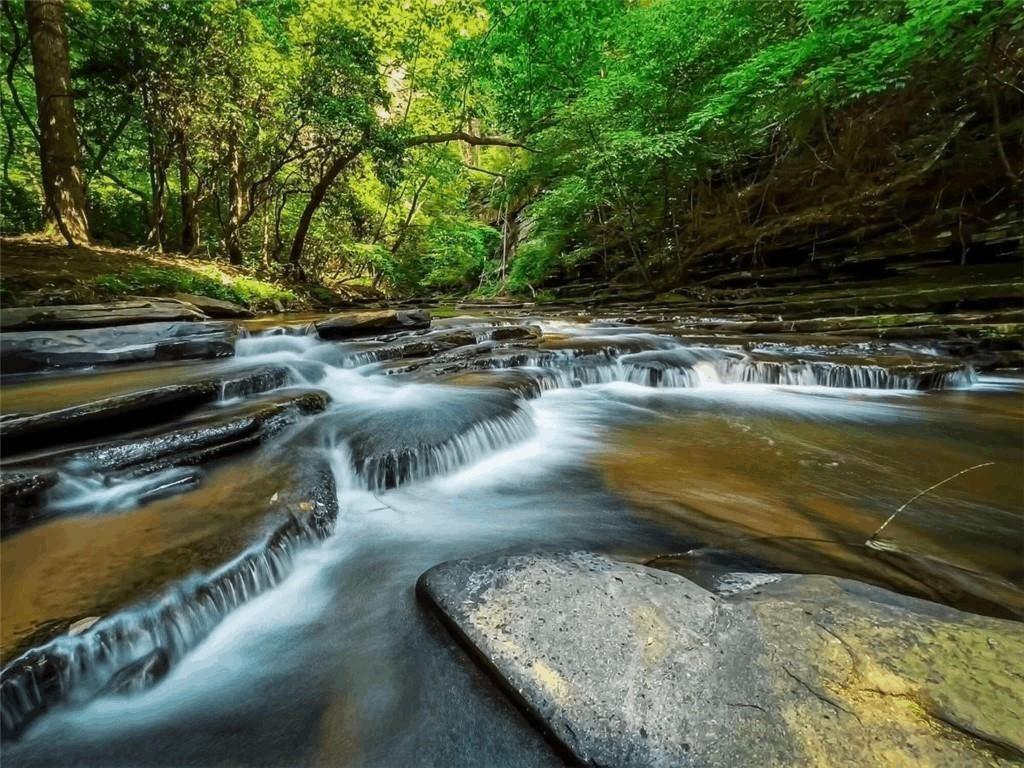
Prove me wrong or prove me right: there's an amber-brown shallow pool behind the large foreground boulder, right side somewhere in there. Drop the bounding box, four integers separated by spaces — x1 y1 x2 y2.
597 390 1024 616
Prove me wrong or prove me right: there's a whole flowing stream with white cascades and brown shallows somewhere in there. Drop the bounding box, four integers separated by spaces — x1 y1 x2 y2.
2 311 1024 766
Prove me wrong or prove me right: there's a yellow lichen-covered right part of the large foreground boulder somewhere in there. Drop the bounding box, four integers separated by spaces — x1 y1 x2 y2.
753 582 1024 768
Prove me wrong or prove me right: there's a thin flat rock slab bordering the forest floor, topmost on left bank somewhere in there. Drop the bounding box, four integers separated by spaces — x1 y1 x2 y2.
0 297 206 332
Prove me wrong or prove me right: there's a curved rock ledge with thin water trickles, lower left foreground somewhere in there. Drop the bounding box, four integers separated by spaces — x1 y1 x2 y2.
0 452 338 740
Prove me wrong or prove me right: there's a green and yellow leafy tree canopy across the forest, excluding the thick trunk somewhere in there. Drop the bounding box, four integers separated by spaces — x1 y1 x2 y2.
0 0 1024 296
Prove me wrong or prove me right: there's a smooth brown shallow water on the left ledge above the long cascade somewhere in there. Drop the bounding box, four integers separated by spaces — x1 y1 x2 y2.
0 454 290 663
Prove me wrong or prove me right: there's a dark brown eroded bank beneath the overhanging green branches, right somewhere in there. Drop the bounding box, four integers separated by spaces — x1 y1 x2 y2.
524 80 1024 297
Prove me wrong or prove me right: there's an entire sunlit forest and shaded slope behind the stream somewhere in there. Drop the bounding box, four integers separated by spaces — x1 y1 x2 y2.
0 0 1024 298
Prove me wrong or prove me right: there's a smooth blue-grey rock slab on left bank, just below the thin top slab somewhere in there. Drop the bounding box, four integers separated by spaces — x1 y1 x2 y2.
0 322 236 375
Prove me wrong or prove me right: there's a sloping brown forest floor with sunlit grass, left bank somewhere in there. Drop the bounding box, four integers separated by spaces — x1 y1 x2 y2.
0 236 379 310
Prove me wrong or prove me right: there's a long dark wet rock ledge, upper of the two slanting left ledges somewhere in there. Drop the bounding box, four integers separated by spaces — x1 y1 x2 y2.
0 366 288 455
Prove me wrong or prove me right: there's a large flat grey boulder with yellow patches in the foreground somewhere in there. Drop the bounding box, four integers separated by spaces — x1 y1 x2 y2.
417 553 1024 768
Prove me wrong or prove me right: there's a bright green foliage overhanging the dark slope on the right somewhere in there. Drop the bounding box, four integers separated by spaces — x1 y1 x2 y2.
475 0 1021 290
